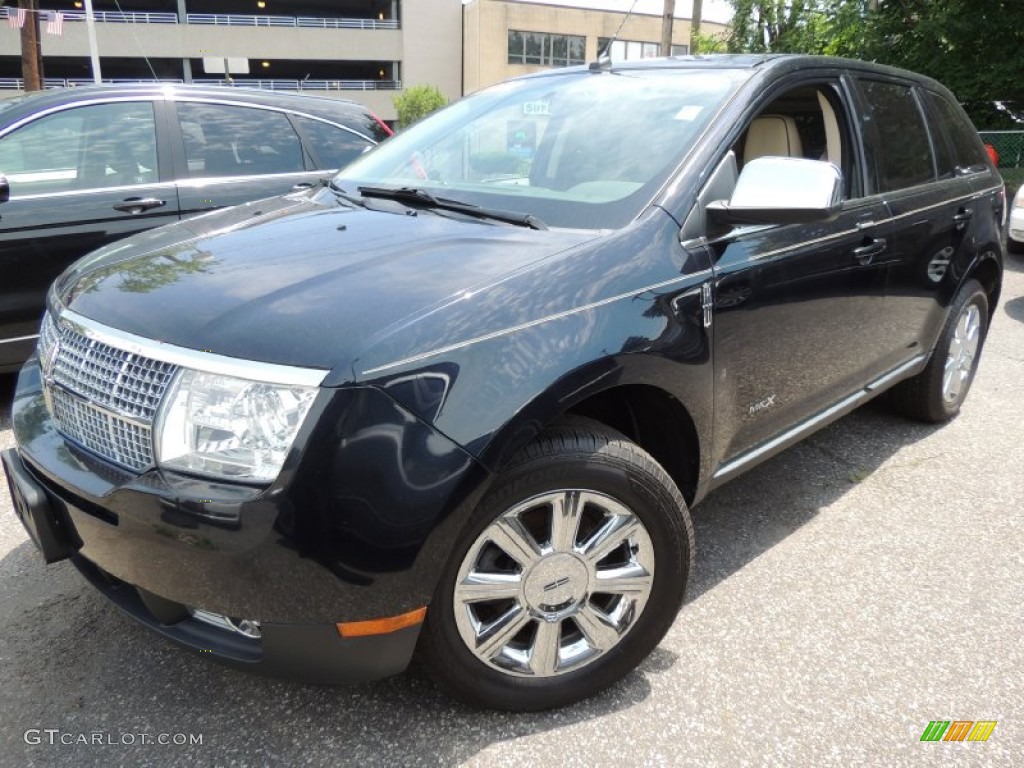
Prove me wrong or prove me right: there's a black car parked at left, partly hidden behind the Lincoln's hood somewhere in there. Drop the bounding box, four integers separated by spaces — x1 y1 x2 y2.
0 84 390 373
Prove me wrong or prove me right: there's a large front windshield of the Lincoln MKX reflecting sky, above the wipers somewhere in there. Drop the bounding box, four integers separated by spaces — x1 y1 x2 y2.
335 70 749 229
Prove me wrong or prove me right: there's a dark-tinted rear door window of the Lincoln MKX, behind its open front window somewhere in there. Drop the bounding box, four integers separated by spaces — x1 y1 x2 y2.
860 80 935 191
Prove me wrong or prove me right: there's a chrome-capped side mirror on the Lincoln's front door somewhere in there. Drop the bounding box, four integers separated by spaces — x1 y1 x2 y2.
708 158 843 226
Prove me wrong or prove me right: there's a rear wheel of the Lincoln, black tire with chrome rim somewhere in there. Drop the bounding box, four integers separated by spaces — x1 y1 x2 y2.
890 280 988 424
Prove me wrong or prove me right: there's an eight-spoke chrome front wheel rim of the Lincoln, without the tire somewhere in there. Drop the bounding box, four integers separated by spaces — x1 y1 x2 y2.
453 489 654 678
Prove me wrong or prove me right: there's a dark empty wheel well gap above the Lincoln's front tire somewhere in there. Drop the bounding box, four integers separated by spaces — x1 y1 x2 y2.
567 384 700 504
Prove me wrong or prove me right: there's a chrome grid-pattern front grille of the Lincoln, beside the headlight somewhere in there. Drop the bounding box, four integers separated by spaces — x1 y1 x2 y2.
40 314 178 472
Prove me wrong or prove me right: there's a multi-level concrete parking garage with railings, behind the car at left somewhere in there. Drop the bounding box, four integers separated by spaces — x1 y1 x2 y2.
0 0 462 120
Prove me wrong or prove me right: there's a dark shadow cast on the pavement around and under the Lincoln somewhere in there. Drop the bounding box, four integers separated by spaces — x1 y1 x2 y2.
0 382 935 768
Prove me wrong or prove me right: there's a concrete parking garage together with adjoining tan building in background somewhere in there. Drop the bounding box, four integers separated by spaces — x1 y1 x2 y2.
0 0 737 121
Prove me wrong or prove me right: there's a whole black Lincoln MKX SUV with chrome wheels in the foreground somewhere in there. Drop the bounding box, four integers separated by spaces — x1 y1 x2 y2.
3 56 1006 710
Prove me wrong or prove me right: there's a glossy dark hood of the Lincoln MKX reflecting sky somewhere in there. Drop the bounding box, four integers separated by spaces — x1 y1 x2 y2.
56 196 595 376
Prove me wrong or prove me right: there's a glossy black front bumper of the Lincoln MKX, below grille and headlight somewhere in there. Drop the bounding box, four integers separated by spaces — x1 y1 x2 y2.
4 360 486 683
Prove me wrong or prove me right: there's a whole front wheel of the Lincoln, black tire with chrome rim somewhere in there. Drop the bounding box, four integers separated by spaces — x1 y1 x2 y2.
421 419 693 711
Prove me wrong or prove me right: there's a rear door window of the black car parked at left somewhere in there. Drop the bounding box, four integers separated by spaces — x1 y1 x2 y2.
178 101 305 178
